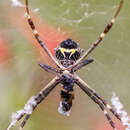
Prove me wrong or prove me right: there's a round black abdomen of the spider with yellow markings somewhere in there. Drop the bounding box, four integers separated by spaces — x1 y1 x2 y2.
55 38 82 67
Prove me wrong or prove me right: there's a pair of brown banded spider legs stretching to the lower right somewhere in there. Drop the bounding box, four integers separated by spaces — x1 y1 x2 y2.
75 76 121 130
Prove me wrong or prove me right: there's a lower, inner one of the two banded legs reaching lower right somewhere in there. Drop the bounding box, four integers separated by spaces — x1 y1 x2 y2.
75 77 116 130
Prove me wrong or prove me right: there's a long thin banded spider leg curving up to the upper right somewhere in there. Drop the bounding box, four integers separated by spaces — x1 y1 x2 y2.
68 0 124 69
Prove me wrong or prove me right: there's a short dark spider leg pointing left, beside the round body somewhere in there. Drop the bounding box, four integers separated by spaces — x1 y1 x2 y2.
38 63 60 74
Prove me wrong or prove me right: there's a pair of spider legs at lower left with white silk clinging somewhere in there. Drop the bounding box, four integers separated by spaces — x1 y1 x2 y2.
7 76 60 130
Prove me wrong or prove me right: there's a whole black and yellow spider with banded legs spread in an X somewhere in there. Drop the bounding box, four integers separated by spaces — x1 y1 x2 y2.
7 0 123 130
